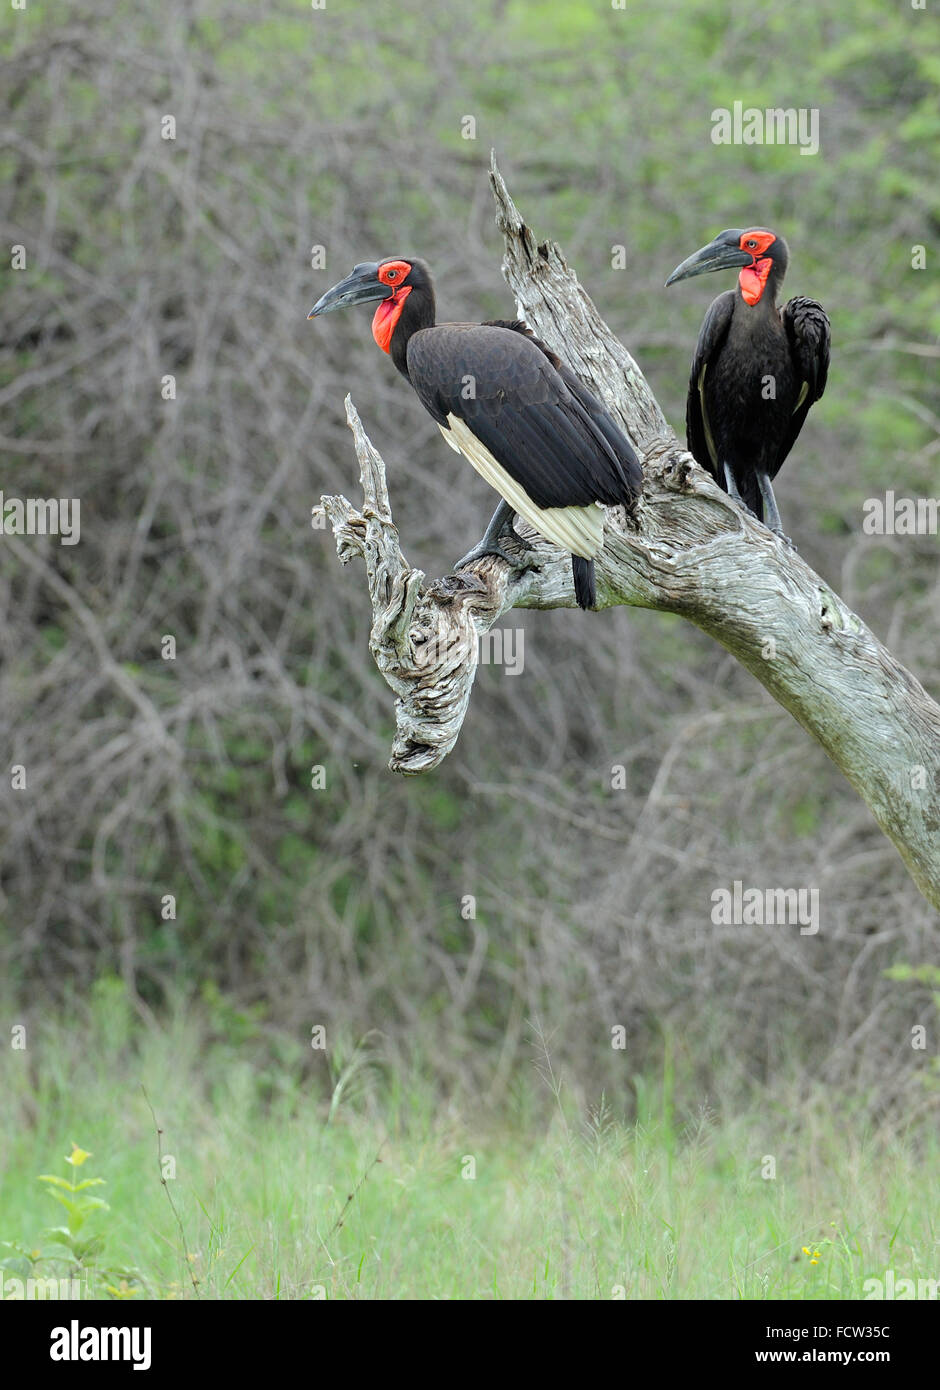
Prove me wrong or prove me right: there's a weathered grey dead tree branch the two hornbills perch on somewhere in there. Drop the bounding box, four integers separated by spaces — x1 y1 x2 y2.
315 160 940 908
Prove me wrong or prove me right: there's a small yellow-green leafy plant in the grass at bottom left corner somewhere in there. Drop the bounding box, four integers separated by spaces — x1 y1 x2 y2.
0 1140 139 1298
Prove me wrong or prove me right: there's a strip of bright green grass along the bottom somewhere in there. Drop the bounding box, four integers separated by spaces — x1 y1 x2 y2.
0 984 940 1300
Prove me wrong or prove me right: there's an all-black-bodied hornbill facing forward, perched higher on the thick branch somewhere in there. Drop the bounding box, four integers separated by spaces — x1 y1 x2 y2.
666 227 829 535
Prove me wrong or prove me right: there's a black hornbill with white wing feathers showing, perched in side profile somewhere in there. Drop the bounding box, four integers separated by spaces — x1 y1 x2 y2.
307 256 642 609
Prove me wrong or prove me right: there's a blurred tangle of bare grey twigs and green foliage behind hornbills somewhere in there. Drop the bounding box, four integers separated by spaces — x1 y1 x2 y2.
0 0 940 1109
